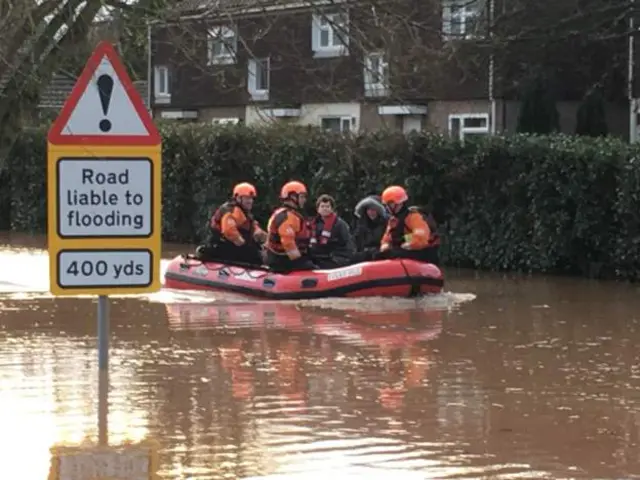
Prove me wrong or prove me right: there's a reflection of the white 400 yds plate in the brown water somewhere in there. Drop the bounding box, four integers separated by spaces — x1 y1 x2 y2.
58 449 150 480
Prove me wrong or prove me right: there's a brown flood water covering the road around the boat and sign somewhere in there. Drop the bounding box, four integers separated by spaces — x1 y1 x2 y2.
0 232 640 480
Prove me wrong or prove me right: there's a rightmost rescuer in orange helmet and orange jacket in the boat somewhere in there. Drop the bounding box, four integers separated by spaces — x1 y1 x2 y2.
378 185 440 265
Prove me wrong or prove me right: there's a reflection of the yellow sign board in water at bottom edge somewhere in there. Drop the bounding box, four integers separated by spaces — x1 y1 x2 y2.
49 440 159 480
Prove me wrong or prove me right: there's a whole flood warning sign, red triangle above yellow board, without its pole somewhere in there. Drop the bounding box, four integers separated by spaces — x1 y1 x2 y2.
47 42 162 295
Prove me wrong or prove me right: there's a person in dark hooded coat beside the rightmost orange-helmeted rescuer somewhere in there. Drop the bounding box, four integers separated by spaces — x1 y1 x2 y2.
353 195 388 263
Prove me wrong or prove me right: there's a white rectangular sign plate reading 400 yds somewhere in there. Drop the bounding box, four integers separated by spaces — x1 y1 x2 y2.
58 250 153 288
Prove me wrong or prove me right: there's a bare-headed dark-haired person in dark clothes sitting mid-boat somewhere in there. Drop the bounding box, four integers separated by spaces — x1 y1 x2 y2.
309 194 356 269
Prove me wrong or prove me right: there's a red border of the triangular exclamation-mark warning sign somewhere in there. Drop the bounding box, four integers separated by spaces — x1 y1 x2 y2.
47 41 162 146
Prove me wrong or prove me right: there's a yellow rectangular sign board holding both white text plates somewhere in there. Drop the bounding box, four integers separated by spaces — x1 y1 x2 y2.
47 144 162 295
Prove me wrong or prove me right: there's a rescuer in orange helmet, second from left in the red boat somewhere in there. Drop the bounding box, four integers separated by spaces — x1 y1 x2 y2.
267 181 318 272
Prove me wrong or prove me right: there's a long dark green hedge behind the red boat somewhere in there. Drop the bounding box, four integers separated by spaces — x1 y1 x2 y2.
5 125 640 279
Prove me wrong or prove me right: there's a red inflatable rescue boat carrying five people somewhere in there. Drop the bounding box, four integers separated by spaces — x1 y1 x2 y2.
164 255 444 300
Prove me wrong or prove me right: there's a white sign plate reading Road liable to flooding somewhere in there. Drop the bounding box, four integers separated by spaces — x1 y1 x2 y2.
56 158 153 238
